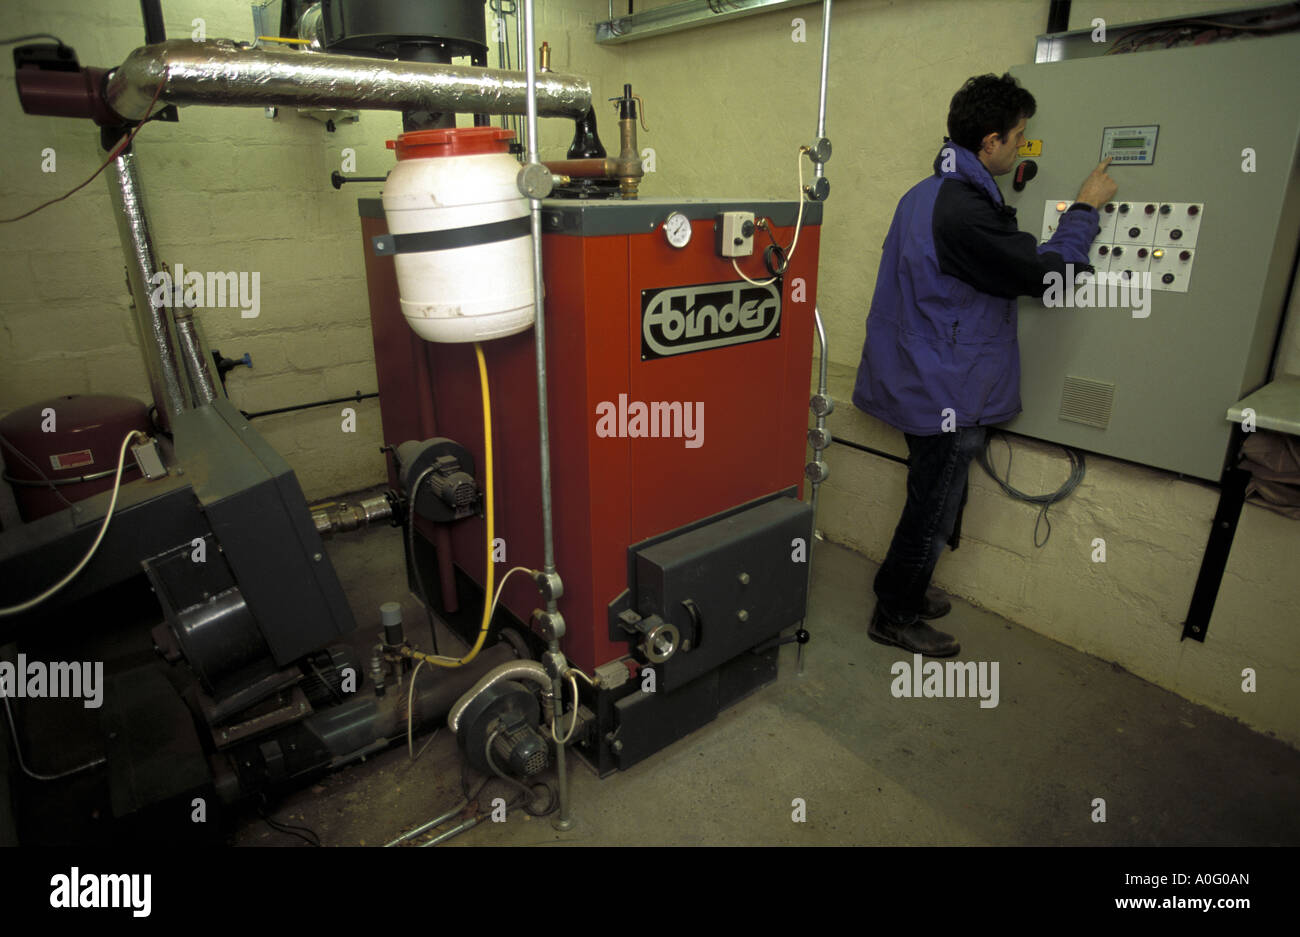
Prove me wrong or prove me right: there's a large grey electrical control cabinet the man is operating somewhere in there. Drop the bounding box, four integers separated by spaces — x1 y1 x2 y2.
1004 35 1300 481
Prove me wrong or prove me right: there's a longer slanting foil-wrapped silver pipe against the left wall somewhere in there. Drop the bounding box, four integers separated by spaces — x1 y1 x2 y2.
104 149 190 429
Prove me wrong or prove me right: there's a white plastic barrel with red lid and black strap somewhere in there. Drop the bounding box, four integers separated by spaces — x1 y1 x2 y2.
384 127 533 342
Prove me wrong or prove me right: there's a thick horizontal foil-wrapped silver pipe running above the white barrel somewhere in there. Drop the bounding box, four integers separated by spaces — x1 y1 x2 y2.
105 39 592 121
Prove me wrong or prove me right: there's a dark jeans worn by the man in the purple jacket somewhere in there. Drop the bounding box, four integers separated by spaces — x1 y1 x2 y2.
875 426 988 624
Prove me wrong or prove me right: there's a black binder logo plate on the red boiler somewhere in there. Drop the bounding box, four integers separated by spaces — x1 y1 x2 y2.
641 279 781 360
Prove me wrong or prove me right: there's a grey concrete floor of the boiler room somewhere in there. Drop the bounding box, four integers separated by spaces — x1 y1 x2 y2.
235 519 1300 846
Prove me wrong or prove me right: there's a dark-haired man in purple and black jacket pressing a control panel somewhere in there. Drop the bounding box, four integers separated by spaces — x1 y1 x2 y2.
853 74 1117 658
